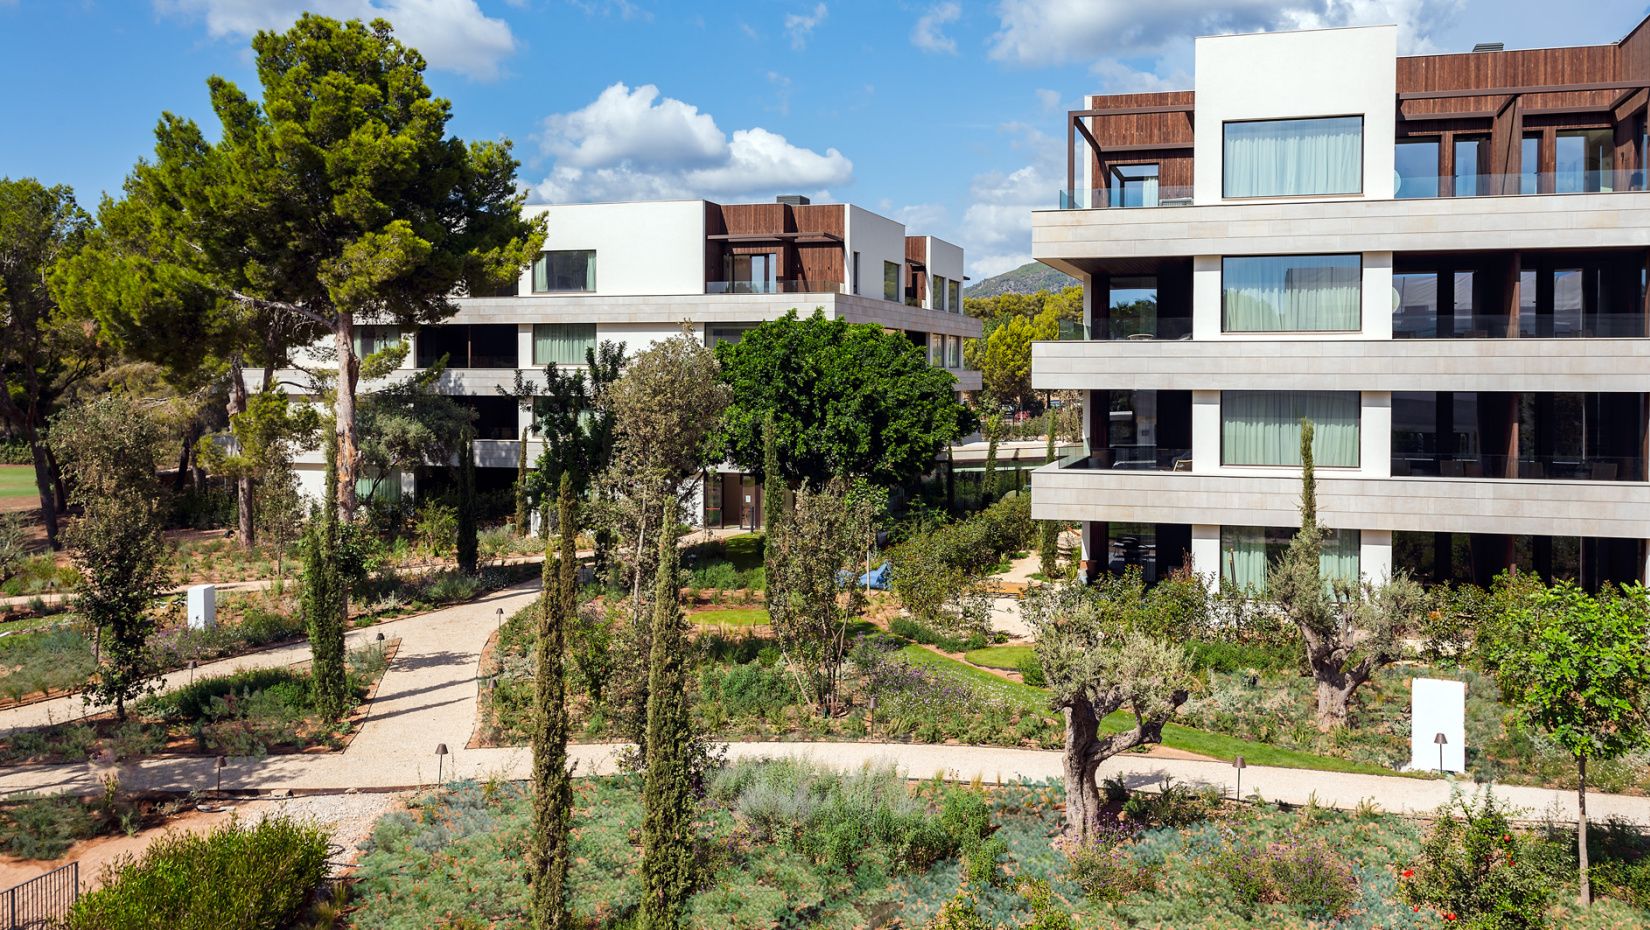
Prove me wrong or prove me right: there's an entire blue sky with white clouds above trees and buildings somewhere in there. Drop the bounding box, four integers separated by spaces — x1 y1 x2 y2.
0 0 1647 280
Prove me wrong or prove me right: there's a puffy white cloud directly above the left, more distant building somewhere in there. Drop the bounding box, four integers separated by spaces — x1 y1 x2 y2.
533 84 853 203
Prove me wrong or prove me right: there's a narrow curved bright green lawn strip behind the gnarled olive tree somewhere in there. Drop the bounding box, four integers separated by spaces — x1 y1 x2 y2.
901 645 1396 775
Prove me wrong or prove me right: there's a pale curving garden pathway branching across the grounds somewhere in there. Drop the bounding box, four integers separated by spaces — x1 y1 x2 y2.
0 580 1650 824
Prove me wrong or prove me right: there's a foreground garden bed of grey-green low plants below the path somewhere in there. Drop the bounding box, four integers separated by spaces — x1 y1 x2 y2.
338 760 1650 930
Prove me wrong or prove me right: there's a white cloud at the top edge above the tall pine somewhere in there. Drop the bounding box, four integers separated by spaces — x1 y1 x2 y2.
155 0 516 81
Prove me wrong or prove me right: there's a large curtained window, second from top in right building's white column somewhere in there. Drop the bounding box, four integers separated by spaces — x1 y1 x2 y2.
1221 256 1363 333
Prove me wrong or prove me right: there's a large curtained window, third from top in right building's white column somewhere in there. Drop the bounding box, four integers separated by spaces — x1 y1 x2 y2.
1221 391 1358 468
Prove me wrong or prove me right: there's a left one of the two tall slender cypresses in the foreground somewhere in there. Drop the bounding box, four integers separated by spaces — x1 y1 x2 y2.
530 472 578 930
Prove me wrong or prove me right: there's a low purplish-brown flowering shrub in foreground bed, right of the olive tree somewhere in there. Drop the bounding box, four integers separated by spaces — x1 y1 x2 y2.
1203 839 1358 920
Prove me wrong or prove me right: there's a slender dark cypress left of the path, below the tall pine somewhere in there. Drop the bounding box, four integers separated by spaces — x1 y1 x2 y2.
300 432 350 722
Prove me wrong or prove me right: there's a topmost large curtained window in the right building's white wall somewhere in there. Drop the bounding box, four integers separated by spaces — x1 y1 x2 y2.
1224 117 1363 198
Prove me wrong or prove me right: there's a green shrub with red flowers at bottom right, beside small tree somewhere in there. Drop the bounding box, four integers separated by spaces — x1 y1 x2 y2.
1399 790 1554 930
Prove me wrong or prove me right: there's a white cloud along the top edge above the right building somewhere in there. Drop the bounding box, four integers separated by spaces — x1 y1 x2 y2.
990 0 1465 64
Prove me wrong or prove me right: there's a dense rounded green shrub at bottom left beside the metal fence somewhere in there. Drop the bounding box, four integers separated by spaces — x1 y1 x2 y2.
68 818 327 930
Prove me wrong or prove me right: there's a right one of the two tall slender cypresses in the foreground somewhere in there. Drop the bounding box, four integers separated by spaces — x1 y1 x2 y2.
640 500 695 930
